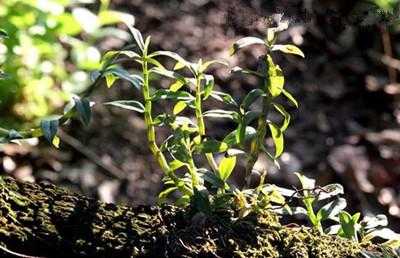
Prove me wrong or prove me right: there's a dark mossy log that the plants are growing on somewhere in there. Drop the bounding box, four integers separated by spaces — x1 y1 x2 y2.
0 177 386 258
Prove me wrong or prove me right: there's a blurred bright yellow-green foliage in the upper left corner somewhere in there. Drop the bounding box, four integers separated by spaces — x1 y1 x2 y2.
0 0 134 126
